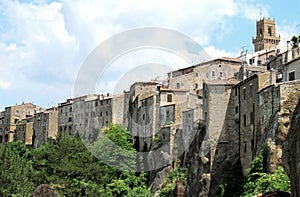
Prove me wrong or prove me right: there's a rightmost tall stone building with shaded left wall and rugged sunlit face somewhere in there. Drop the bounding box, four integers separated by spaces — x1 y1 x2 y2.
256 80 300 173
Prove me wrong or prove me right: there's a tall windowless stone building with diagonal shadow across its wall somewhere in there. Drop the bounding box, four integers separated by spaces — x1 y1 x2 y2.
199 79 239 196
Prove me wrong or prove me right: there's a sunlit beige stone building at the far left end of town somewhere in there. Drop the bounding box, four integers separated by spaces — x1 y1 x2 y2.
0 102 43 143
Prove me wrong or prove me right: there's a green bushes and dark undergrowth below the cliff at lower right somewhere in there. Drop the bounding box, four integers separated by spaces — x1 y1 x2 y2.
217 148 290 197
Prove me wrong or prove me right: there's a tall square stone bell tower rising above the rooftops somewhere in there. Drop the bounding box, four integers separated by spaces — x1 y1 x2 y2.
252 18 280 52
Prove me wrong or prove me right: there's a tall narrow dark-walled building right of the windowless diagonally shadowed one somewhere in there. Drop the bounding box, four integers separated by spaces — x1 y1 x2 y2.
235 72 271 175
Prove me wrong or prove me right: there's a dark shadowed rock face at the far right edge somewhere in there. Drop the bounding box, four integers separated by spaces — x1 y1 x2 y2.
283 102 300 197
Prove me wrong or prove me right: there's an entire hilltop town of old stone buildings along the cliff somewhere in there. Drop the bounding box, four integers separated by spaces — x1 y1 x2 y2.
0 18 300 196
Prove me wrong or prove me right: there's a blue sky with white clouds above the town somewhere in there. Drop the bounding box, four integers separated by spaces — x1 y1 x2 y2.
0 0 300 110
